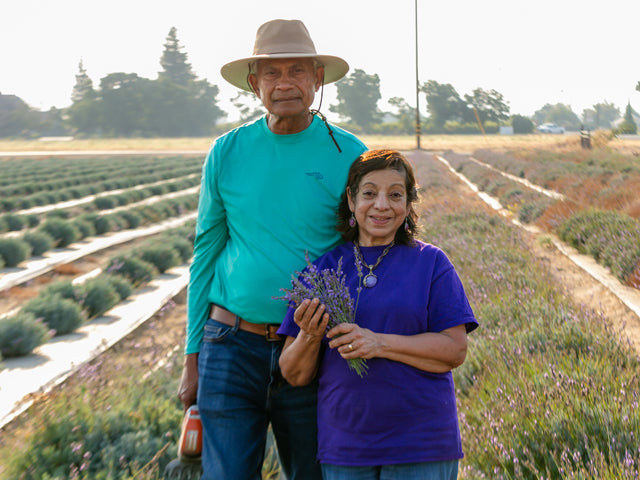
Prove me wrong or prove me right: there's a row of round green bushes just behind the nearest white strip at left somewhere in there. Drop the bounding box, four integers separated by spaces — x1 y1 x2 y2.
0 222 194 359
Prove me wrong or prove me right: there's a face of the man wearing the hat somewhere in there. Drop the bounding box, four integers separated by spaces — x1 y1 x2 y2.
249 58 324 118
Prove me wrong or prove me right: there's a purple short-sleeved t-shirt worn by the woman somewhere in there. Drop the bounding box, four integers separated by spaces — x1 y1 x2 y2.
279 242 478 465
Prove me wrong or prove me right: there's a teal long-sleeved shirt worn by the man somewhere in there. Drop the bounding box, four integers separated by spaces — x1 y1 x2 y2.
185 117 366 354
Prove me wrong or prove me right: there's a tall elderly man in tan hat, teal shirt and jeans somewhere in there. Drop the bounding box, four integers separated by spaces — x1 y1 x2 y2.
178 20 366 480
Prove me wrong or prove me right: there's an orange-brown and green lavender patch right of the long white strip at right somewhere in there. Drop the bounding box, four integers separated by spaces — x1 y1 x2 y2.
445 150 640 288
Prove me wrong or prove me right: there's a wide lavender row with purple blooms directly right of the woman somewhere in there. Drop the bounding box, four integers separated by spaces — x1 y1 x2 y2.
416 156 640 480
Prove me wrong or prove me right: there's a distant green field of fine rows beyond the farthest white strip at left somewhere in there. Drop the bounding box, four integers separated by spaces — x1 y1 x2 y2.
0 157 202 212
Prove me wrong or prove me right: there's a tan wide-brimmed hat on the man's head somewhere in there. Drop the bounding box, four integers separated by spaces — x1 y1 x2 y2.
220 19 349 92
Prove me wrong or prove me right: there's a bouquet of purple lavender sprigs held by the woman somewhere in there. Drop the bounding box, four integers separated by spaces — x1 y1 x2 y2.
278 253 368 377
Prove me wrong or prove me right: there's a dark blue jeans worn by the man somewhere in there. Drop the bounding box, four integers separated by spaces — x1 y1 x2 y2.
198 319 322 480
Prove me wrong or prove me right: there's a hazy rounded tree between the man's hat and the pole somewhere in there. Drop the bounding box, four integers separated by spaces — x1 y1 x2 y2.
329 69 381 132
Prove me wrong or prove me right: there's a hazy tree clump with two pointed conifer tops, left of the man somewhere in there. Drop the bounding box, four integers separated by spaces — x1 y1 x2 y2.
68 28 224 137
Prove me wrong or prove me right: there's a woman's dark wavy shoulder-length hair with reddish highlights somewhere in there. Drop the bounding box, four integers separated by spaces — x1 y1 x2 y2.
336 149 418 245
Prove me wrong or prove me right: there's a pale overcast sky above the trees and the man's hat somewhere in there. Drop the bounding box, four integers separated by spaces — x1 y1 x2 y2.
0 0 640 122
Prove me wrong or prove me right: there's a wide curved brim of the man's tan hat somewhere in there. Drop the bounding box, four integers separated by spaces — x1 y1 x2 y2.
220 53 349 92
